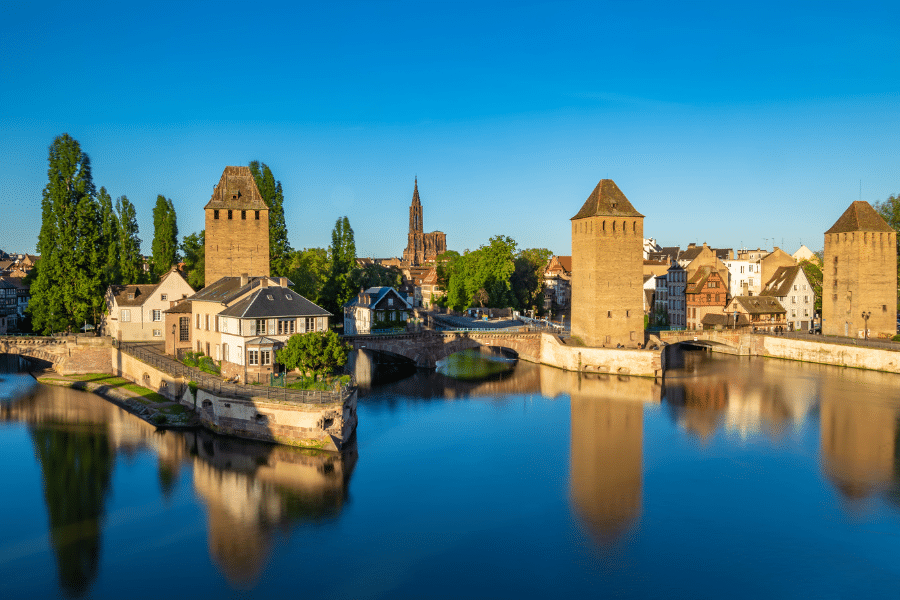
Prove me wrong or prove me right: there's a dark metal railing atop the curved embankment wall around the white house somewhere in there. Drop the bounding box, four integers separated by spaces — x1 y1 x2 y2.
118 343 354 404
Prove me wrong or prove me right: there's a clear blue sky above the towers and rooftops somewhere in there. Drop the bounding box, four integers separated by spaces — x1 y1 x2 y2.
0 0 900 256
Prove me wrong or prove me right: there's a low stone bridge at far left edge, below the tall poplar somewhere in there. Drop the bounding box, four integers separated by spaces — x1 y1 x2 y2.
0 335 112 375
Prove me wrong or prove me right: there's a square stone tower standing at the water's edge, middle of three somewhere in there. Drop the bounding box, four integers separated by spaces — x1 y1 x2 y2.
572 179 644 348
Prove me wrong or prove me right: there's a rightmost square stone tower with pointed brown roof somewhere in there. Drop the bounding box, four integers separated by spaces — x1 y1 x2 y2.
822 201 897 338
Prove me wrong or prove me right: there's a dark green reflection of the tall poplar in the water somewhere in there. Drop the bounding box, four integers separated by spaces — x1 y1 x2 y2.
31 425 113 596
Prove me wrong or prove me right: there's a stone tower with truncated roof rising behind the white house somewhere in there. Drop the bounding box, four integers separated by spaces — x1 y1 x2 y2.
205 167 269 285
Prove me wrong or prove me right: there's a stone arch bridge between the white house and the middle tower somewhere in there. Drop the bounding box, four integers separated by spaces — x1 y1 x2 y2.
344 330 541 369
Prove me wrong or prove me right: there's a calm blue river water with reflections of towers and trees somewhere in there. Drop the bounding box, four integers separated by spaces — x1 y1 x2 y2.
0 353 900 598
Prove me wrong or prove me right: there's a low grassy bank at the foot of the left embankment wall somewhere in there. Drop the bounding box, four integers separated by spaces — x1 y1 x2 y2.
31 371 200 429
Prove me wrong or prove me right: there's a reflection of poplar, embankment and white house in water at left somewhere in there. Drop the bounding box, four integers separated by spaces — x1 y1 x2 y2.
0 378 357 596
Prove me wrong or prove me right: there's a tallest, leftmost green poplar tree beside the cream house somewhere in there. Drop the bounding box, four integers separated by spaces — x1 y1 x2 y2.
29 134 103 333
